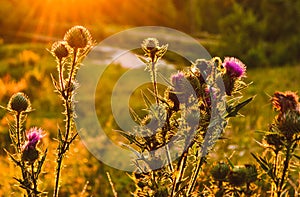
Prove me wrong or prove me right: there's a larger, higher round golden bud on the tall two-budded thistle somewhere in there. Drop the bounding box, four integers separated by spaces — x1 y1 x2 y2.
64 26 92 49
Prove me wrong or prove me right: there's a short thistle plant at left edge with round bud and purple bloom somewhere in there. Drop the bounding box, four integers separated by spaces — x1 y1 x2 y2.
2 92 47 197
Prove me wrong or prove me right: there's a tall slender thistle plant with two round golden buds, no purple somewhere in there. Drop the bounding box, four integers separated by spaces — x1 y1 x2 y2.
50 26 94 197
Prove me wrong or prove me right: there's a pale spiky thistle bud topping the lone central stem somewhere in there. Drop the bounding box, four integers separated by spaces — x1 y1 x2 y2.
141 38 168 62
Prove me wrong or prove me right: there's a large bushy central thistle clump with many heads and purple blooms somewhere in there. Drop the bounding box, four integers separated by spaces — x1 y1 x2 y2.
120 38 252 197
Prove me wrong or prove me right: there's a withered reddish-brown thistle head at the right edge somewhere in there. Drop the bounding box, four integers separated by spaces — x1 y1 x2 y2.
271 91 300 113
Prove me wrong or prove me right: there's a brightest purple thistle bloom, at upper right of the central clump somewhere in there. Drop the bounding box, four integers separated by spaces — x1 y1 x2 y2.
223 57 246 78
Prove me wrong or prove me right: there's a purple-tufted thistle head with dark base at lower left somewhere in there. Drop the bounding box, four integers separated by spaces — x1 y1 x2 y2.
22 127 44 163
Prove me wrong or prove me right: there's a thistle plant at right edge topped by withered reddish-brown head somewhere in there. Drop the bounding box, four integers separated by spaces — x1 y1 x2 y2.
252 91 300 197
